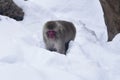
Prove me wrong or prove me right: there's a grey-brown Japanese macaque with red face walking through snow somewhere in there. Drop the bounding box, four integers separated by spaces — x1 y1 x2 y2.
43 20 76 55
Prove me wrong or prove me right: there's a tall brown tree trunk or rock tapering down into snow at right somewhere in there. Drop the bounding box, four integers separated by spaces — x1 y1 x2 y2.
100 0 120 41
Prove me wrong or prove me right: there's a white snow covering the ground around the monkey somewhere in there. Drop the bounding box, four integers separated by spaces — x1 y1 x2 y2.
0 0 120 80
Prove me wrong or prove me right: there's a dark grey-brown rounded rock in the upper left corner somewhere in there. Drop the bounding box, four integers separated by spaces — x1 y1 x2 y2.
0 0 24 21
